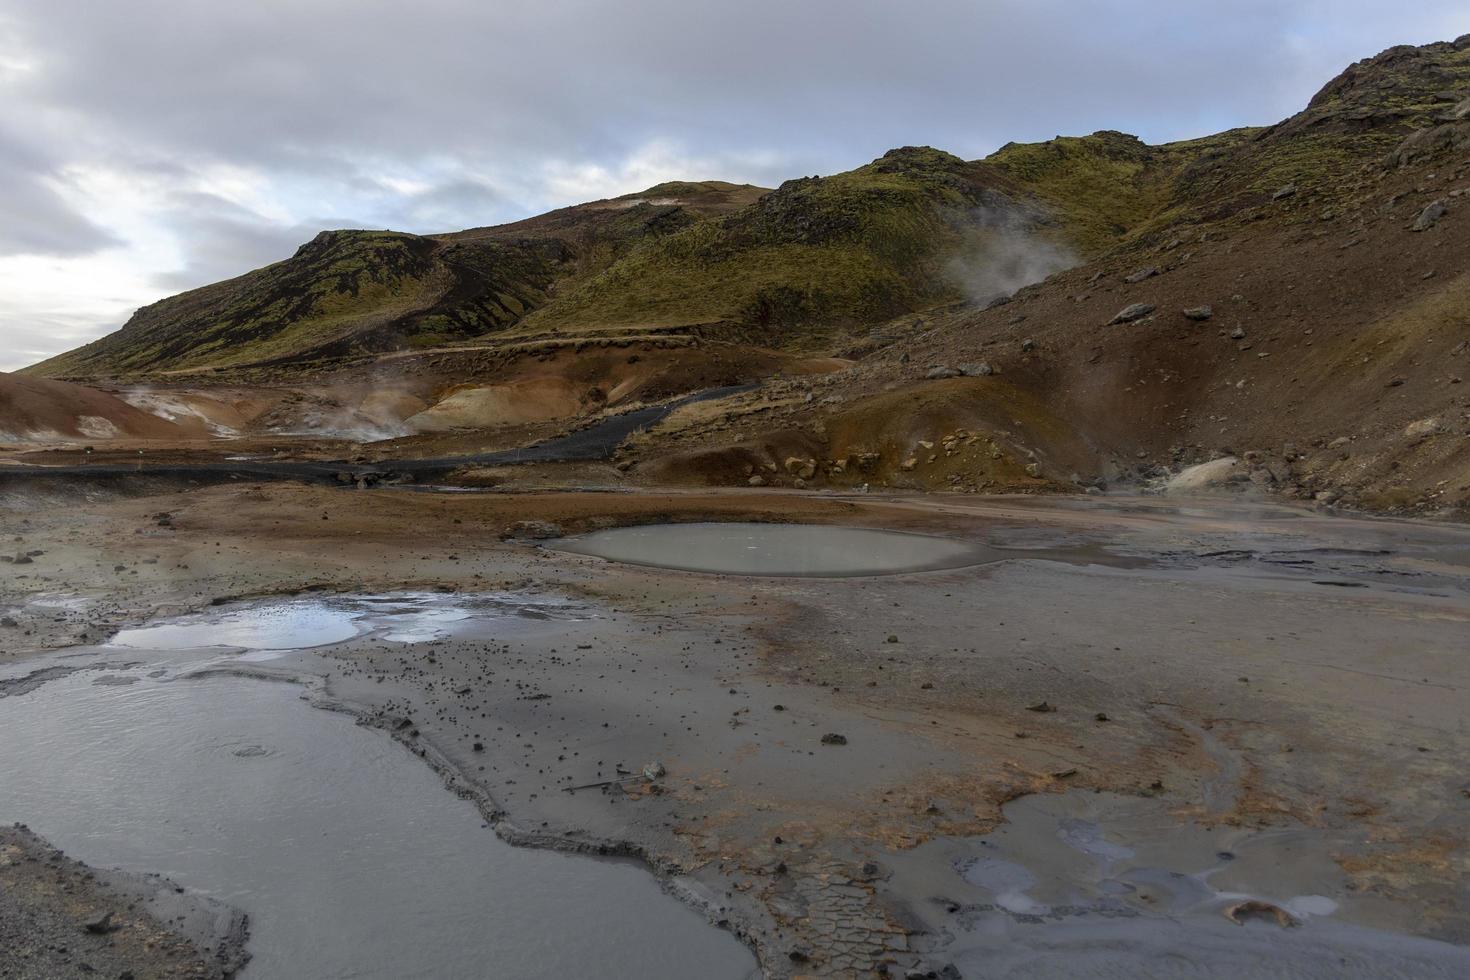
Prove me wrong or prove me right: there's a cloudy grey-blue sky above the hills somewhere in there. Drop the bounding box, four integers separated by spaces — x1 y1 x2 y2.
0 0 1470 370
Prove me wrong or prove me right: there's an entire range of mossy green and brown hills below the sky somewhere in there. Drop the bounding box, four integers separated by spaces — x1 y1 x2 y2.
14 35 1470 510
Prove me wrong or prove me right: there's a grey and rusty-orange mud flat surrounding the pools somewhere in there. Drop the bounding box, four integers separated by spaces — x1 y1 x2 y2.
0 486 1470 977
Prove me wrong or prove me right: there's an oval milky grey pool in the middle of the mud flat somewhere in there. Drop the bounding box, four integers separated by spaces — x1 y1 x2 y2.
554 523 1005 576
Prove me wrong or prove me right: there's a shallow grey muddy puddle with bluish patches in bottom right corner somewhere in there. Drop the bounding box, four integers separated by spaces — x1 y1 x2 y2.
889 792 1470 980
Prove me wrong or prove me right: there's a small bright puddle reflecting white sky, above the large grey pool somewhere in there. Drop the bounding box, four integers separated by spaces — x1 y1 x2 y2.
107 592 578 661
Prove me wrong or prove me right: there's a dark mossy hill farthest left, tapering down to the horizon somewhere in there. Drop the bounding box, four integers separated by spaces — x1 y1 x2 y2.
28 181 763 378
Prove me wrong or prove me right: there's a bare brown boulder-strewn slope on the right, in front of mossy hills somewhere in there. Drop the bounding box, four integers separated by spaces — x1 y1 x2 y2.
648 35 1470 516
